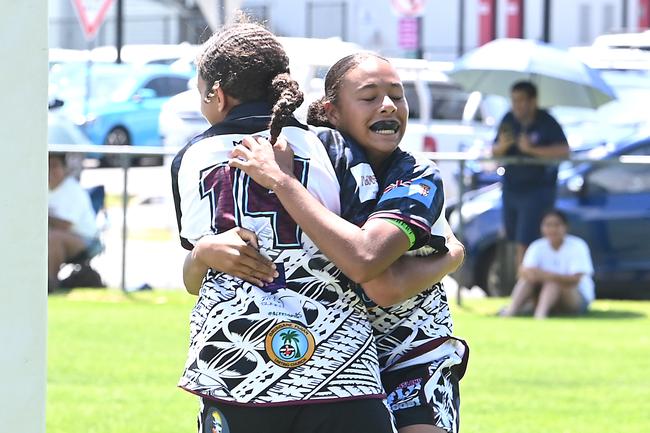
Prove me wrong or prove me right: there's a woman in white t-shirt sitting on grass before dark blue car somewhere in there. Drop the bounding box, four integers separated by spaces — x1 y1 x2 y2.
501 210 595 319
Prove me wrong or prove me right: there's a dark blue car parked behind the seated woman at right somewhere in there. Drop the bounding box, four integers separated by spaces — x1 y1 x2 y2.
450 131 650 299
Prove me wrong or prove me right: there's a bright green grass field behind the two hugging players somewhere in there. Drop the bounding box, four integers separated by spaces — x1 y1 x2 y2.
47 290 650 433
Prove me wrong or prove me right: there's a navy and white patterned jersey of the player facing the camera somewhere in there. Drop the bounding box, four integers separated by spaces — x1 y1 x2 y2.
317 128 466 370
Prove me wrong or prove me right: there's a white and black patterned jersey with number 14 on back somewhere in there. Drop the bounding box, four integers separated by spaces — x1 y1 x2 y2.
172 104 383 405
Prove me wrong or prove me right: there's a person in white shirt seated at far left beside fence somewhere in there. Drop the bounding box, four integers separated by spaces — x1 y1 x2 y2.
48 154 99 292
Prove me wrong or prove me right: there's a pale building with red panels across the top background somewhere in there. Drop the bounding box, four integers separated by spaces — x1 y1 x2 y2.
49 0 650 60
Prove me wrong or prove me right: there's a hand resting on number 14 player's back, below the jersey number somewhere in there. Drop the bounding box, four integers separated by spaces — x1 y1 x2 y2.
192 227 277 287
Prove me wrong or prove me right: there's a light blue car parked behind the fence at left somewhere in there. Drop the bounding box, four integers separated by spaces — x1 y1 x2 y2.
50 63 195 159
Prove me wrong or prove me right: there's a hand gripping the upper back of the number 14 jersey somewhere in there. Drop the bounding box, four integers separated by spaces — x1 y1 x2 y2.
228 136 293 189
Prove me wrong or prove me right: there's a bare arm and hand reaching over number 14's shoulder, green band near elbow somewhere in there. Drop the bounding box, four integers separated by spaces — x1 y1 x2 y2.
229 137 412 283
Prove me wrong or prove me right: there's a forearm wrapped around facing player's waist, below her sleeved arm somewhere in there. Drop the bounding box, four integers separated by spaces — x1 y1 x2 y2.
362 221 465 307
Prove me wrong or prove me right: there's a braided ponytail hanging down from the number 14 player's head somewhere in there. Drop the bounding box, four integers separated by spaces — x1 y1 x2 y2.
269 72 304 144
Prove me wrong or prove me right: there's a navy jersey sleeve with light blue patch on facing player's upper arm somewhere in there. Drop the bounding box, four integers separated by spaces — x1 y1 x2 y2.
369 152 445 250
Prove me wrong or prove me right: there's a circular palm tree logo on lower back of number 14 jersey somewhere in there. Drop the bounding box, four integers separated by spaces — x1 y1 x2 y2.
265 322 316 368
